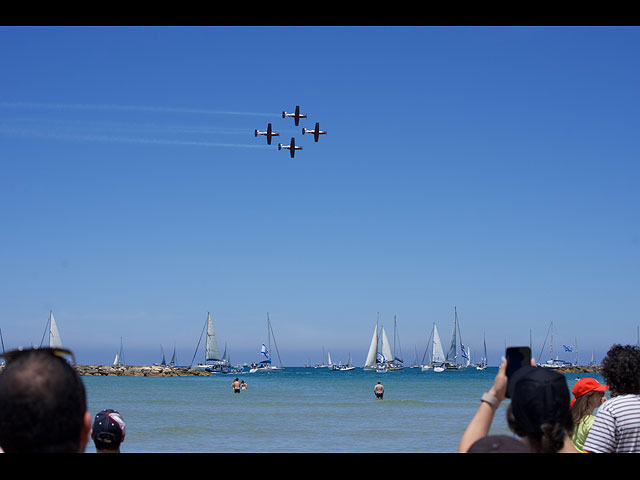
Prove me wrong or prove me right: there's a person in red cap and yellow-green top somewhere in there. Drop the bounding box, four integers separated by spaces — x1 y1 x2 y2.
571 378 609 450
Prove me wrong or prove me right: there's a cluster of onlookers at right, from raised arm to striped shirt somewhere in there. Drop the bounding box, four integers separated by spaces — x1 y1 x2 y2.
458 345 640 453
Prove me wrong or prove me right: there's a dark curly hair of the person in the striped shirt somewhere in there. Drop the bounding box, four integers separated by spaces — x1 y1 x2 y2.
601 344 640 397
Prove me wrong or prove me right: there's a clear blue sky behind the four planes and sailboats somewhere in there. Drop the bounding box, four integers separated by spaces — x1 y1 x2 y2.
0 27 640 366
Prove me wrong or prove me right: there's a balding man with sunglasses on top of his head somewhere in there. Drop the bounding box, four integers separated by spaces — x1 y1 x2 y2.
0 348 91 453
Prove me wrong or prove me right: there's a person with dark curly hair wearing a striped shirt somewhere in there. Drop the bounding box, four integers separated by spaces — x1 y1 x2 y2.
583 344 640 453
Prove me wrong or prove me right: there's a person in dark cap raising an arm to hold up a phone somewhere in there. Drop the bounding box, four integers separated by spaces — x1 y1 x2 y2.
458 360 578 453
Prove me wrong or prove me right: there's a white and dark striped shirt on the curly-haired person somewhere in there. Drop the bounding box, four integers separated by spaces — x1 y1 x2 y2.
583 394 640 453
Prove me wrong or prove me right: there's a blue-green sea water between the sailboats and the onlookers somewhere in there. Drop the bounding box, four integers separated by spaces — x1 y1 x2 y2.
83 367 602 453
